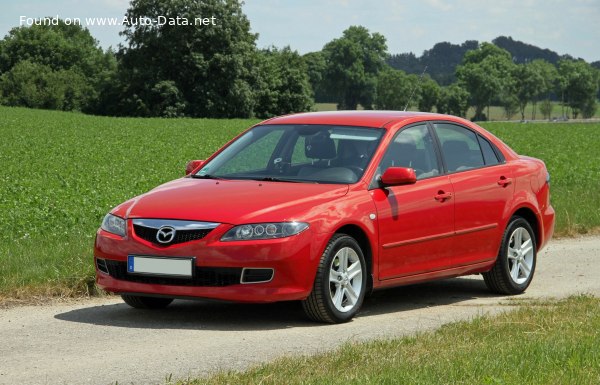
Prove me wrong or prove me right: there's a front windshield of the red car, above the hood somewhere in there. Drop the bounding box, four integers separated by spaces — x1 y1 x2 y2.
193 125 383 184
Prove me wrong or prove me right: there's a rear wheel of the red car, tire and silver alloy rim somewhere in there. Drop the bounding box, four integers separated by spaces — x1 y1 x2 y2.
483 216 537 294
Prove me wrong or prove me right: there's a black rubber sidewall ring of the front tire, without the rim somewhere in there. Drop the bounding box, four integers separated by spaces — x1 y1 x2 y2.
320 235 368 322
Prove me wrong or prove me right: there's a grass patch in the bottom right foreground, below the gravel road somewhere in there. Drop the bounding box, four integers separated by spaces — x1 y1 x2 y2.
177 296 600 385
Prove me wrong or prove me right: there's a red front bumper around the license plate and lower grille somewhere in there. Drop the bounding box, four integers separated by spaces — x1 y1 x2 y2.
94 221 328 303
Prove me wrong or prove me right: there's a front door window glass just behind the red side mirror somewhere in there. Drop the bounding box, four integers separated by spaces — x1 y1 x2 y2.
379 124 440 179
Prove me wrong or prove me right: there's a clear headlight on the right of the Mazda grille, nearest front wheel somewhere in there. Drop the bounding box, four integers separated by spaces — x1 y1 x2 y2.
221 222 308 241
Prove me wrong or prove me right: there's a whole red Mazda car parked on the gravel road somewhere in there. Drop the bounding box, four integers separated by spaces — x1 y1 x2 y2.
94 111 554 323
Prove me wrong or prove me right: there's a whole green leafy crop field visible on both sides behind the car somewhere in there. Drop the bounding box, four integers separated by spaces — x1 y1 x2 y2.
0 107 600 298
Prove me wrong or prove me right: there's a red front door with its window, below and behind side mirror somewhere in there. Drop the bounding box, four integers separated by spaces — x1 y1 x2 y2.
371 124 454 279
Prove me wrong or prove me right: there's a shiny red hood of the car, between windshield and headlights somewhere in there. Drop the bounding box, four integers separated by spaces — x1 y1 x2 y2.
117 178 348 224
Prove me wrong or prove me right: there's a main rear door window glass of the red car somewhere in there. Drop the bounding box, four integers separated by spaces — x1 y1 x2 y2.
434 123 485 172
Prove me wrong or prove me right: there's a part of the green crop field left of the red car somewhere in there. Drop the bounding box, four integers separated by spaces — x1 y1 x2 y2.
0 107 255 298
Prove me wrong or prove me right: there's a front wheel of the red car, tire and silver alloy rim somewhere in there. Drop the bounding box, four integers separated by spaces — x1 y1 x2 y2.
302 234 368 323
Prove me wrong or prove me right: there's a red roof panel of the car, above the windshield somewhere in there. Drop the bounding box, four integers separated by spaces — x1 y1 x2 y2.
261 110 462 128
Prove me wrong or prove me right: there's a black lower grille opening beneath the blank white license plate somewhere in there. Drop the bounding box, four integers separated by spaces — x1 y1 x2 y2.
105 259 242 287
